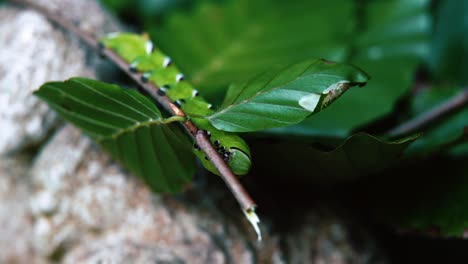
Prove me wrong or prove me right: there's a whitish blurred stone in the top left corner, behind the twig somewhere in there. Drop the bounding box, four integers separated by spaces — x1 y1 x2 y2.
0 0 117 155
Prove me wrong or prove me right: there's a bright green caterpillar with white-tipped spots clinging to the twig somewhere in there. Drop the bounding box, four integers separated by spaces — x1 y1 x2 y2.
100 33 251 175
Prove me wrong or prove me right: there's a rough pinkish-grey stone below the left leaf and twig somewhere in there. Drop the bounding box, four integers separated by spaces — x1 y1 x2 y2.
31 126 253 263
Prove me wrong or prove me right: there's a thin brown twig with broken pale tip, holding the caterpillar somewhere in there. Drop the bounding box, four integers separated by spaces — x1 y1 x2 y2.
10 0 256 218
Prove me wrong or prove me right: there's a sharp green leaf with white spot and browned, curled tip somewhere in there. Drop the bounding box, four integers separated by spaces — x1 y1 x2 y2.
207 60 368 132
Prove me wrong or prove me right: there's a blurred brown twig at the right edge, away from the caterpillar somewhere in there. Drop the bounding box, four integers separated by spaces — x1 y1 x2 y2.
386 88 468 137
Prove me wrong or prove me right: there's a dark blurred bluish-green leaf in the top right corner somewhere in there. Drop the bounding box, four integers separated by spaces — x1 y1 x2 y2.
429 0 468 85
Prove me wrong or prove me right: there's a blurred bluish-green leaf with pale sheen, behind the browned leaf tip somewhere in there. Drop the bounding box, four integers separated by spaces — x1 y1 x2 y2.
277 0 430 138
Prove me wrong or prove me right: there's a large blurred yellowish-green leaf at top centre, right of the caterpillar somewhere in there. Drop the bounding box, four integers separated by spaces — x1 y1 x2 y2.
150 0 354 100
